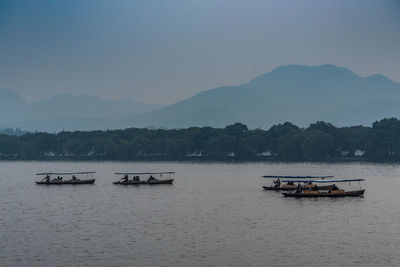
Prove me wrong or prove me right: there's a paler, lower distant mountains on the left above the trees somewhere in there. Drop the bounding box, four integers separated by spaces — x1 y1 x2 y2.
0 90 161 131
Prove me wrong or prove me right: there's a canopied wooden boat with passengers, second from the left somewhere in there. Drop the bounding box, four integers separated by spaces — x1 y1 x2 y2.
113 172 175 185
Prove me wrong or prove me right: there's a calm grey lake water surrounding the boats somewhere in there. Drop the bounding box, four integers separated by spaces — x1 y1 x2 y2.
0 162 400 266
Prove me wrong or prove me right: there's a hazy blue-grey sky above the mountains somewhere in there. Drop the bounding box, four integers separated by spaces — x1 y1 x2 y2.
0 0 400 104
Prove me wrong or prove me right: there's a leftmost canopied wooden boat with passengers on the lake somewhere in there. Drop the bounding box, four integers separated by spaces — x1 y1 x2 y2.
36 172 96 185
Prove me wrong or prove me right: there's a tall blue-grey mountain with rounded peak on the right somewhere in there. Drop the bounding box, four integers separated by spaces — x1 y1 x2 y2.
125 65 400 128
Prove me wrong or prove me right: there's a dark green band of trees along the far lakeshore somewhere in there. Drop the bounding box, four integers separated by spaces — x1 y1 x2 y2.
0 118 400 161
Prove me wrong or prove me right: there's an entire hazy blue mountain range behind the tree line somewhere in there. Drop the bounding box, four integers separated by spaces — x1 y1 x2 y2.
0 65 400 131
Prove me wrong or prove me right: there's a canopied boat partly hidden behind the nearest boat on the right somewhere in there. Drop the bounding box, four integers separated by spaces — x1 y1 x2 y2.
262 175 334 191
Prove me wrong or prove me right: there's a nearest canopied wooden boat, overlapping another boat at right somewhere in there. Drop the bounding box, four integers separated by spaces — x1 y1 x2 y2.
282 179 365 198
